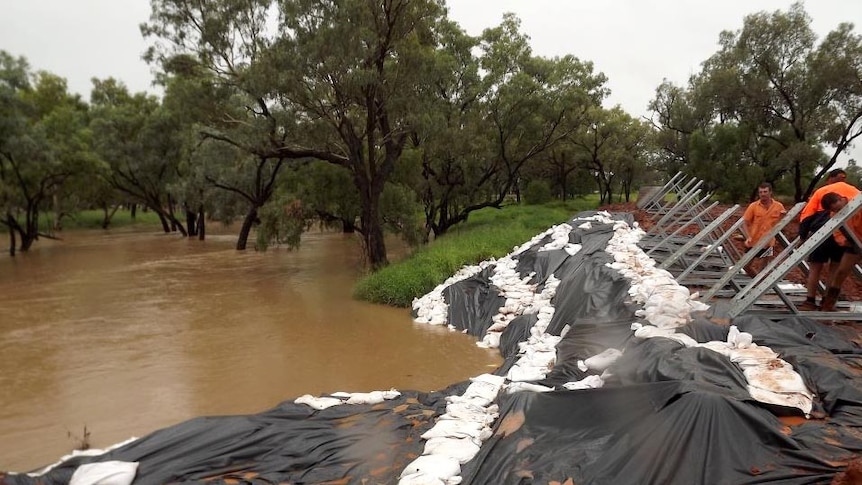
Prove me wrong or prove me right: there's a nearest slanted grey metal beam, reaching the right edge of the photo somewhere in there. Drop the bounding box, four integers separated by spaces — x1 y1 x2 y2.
728 197 862 318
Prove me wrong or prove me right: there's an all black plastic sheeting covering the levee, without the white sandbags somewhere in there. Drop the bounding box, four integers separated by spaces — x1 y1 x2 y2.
5 213 862 485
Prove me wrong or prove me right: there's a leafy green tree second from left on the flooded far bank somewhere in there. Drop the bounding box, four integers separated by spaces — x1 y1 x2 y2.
90 78 187 236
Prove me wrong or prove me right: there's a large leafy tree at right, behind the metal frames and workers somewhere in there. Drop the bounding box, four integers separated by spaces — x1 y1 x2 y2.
650 3 862 200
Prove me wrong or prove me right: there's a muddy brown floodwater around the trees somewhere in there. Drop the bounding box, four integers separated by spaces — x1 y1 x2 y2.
0 231 501 471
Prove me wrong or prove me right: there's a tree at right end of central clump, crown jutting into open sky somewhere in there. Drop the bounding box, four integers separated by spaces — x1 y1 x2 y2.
480 14 609 206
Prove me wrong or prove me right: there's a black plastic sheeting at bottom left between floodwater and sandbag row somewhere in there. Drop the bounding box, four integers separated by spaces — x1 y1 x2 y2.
0 383 466 485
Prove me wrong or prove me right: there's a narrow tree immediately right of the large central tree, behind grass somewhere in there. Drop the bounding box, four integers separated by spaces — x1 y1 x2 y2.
404 21 499 240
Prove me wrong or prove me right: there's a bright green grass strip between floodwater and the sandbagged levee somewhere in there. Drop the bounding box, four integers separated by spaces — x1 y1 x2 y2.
354 196 598 307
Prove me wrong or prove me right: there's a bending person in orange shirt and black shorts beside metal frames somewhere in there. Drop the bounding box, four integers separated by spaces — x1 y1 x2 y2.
799 168 859 310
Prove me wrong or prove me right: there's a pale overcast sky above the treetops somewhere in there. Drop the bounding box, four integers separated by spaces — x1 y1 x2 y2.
0 0 862 159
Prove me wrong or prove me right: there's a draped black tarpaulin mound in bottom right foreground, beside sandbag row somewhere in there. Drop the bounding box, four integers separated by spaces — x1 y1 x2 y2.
464 381 835 485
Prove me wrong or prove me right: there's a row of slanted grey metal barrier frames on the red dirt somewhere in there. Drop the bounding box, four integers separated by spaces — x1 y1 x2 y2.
639 173 862 320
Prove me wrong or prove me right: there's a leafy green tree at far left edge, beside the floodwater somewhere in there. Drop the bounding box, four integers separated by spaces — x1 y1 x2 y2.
0 51 94 256
